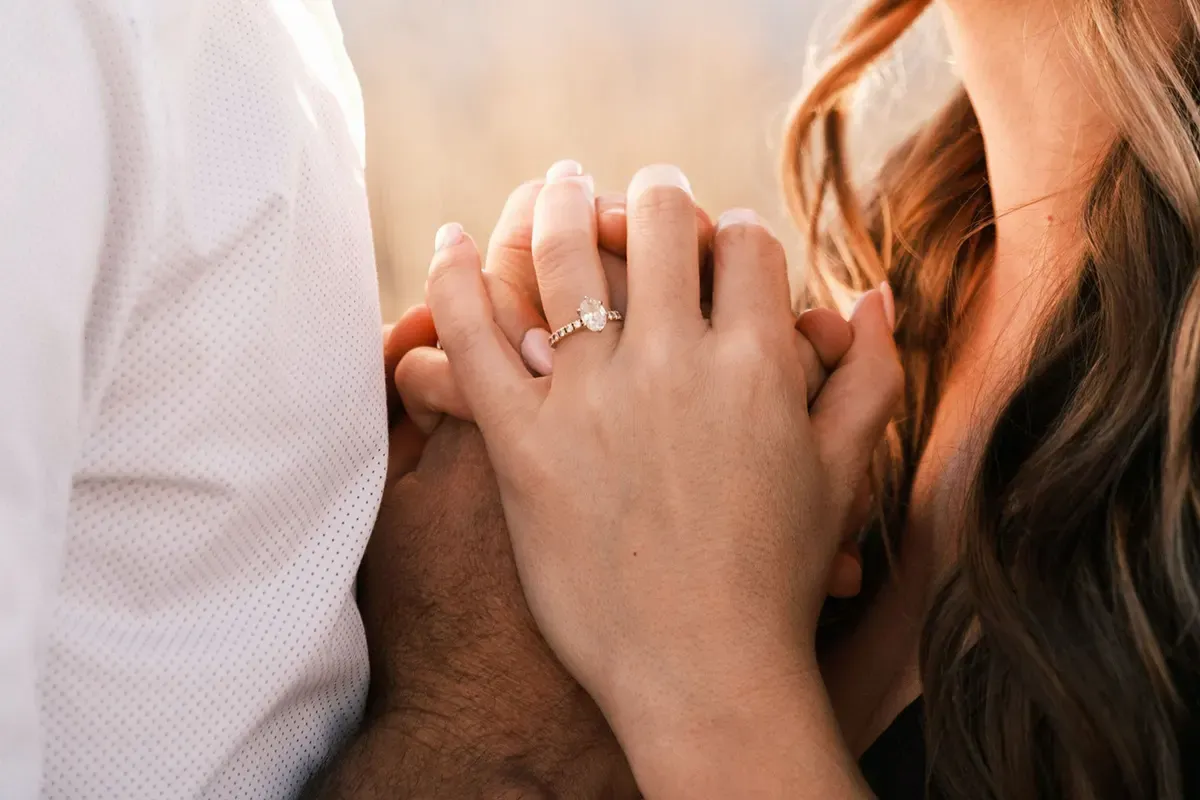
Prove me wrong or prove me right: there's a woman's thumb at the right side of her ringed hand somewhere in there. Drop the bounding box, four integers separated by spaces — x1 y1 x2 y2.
811 283 904 503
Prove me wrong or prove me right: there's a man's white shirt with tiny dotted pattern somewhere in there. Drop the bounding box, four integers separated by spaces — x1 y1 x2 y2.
0 0 386 800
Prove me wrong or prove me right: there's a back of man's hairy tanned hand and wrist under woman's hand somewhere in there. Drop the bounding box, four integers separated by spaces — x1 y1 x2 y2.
310 420 638 799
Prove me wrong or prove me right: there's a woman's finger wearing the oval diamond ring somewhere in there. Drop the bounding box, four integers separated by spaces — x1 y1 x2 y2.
533 162 610 353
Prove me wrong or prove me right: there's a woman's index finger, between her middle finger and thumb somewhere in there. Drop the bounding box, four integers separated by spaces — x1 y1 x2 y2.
713 209 796 332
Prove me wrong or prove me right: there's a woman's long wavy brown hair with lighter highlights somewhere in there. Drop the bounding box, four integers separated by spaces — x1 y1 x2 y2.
784 0 1200 800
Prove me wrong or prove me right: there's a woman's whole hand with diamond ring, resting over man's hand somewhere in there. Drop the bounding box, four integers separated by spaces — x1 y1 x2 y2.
428 160 901 796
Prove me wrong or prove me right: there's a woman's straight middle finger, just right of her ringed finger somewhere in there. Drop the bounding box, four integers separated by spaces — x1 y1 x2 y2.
625 164 707 342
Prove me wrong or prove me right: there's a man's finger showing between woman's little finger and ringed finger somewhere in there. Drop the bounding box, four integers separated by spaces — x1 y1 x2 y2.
484 180 546 348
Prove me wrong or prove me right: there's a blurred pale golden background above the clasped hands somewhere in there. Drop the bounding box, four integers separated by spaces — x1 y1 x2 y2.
338 0 946 319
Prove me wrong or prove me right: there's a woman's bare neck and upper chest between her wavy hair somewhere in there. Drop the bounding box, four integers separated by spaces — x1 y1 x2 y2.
822 0 1169 754
